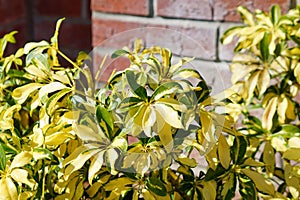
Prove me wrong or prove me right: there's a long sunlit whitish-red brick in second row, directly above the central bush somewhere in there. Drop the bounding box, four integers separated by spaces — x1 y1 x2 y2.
92 18 217 59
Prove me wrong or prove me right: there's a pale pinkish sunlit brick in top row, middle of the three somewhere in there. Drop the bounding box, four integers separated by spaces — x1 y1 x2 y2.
157 0 213 20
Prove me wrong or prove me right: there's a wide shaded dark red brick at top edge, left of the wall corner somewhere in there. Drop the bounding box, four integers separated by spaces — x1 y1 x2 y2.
34 0 82 17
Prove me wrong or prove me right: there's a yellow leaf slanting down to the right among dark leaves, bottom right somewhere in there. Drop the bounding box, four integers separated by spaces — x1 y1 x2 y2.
241 169 275 195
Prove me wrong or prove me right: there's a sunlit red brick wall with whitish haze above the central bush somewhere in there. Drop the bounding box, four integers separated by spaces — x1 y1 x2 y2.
91 0 296 88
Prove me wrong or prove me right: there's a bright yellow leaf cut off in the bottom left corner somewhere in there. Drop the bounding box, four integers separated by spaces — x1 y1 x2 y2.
0 177 18 200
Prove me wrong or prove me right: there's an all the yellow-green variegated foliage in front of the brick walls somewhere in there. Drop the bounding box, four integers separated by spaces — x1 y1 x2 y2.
0 6 300 200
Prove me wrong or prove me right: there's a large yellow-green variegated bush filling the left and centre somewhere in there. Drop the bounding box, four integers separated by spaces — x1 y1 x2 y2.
0 19 234 200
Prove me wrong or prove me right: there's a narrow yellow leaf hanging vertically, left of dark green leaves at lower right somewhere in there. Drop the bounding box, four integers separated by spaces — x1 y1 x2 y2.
218 134 231 169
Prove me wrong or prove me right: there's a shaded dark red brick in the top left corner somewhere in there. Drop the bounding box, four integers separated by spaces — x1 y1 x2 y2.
0 0 26 25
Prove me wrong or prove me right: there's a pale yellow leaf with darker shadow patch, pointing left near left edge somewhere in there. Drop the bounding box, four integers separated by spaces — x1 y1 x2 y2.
12 83 43 104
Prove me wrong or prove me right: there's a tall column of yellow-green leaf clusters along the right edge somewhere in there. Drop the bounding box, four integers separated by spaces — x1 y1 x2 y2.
220 5 300 199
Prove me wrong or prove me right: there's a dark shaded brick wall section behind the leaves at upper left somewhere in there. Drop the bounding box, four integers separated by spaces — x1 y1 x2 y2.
0 0 91 57
